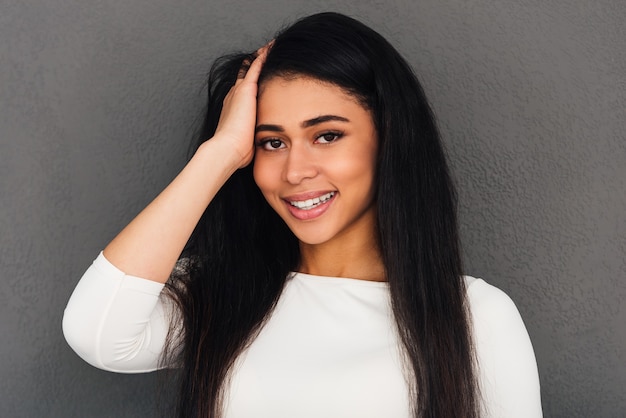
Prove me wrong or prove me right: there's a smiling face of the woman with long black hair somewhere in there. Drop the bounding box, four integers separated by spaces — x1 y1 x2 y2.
254 76 378 244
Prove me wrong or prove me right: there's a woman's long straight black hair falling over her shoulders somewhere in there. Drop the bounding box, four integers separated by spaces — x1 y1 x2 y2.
162 13 478 417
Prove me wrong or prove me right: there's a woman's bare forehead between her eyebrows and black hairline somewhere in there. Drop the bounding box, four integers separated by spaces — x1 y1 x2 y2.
257 76 370 119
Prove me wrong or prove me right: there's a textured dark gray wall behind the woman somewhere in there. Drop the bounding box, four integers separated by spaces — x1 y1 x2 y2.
0 0 626 417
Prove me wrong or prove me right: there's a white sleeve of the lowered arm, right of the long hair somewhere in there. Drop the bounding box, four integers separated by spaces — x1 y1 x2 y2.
468 279 543 418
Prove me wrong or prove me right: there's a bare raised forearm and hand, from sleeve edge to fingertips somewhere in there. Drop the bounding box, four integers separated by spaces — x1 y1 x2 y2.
99 45 270 283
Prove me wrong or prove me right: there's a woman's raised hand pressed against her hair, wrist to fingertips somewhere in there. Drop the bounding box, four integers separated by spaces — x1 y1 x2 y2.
211 43 271 168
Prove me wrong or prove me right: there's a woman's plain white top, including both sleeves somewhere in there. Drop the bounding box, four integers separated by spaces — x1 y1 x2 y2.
63 254 542 418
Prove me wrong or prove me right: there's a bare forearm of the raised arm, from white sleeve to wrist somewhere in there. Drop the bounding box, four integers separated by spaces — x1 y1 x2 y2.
104 138 241 283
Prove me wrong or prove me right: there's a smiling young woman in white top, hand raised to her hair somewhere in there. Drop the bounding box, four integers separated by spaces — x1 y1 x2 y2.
63 13 541 418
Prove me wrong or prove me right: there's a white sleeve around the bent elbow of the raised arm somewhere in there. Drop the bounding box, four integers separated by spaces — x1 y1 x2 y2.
63 253 174 373
